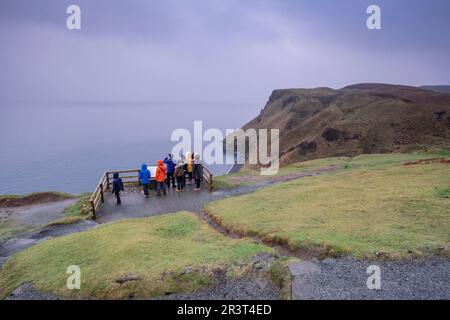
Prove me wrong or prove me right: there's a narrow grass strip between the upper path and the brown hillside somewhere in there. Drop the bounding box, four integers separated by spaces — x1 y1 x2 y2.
213 149 450 190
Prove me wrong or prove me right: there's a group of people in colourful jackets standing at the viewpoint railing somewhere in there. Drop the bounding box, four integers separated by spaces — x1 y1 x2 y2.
112 153 203 205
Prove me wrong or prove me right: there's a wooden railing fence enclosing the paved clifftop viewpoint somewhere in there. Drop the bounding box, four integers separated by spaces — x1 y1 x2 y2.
89 165 213 220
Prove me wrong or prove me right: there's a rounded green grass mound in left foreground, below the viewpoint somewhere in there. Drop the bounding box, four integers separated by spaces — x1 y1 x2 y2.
0 212 273 299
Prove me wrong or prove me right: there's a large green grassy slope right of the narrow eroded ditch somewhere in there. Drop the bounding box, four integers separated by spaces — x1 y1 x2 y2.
205 153 450 258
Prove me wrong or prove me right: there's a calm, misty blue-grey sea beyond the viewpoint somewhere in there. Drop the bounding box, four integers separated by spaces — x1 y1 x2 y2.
0 102 261 194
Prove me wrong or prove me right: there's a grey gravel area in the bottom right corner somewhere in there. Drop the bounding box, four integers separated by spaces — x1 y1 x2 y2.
293 257 450 300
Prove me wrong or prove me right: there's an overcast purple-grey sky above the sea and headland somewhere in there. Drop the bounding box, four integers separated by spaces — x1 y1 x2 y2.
0 0 450 103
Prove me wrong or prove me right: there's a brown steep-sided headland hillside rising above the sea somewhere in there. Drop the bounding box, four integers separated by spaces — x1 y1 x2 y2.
237 84 450 164
